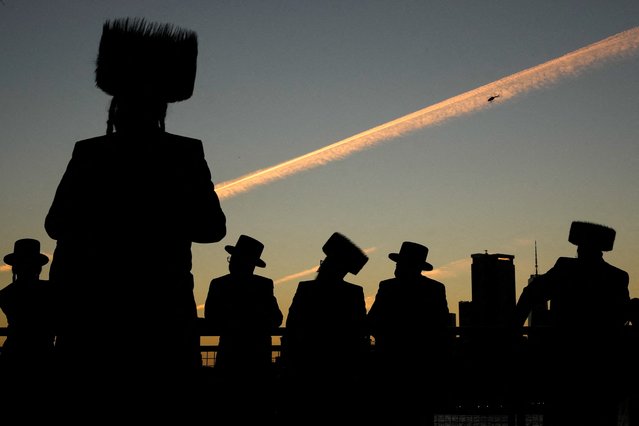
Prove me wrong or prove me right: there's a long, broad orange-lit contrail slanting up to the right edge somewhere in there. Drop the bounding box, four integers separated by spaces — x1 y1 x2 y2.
216 27 639 200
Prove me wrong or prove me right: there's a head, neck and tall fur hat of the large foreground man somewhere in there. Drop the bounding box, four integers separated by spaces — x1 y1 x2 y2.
95 18 198 133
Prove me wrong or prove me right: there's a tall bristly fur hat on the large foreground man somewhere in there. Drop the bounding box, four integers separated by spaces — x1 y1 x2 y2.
95 18 198 102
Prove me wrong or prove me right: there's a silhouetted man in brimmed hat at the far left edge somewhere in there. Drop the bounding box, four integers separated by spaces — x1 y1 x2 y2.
0 238 56 423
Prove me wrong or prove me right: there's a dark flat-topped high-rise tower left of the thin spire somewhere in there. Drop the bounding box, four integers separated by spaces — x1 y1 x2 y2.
471 253 516 326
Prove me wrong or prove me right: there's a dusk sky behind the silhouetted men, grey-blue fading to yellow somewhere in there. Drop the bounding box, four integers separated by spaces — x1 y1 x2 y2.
0 0 639 325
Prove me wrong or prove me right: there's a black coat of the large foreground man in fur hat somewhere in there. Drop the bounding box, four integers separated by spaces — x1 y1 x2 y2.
45 130 226 365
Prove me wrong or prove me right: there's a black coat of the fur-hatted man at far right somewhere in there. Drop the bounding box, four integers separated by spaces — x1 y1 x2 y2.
516 257 634 399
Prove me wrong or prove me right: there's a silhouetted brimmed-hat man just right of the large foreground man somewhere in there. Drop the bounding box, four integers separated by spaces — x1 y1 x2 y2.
204 235 283 424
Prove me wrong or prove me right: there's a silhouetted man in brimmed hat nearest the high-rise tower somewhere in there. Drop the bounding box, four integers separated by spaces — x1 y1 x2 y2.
367 241 451 425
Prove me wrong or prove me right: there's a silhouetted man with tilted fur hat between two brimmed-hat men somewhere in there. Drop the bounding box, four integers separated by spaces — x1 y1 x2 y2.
282 232 369 424
